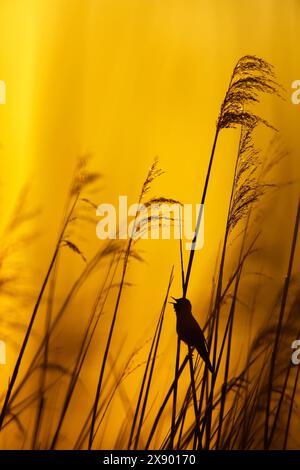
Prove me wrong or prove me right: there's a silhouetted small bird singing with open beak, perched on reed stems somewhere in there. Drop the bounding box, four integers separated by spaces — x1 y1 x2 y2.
171 297 214 373
